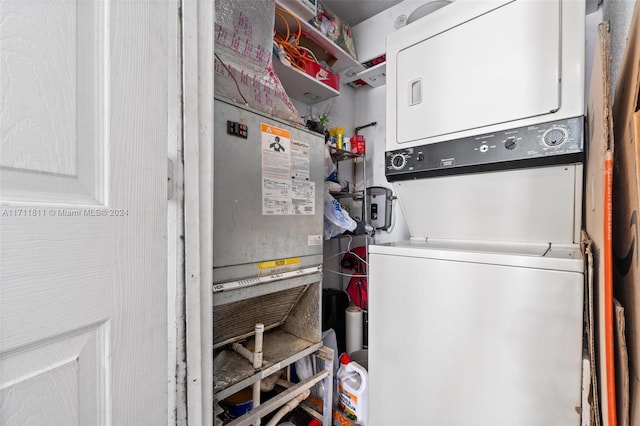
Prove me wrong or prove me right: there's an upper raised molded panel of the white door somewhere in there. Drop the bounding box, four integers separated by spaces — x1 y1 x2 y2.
0 1 111 206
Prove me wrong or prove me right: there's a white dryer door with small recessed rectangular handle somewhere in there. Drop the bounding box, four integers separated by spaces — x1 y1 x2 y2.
395 0 561 144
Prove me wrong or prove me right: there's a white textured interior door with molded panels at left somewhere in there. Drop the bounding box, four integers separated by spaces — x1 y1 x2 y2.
0 0 169 425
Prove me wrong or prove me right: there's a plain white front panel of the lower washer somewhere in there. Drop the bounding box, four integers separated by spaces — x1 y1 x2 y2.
369 253 583 426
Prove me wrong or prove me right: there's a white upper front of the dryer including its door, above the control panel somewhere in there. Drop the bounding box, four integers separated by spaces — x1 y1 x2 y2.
386 0 585 150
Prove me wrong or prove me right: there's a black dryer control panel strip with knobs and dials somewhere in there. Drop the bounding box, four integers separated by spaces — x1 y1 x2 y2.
385 117 584 182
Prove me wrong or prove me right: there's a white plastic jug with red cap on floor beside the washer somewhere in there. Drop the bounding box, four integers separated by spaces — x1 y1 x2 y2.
338 354 369 425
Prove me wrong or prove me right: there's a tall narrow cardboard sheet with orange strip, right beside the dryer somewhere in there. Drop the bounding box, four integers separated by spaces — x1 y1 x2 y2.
584 23 617 426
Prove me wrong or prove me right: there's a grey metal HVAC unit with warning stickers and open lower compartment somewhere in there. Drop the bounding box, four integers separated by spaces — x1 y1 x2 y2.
213 100 333 426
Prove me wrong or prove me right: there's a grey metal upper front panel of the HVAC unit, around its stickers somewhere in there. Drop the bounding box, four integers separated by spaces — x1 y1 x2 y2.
213 100 324 274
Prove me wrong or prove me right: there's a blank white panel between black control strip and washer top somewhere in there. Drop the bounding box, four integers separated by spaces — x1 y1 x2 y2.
394 165 582 243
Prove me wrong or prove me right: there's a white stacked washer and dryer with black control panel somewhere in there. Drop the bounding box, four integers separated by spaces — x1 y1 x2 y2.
369 0 585 426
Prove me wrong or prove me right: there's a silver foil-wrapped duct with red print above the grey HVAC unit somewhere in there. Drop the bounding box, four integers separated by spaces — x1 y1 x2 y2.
214 0 304 124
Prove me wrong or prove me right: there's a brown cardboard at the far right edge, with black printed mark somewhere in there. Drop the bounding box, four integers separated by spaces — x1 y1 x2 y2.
613 1 640 426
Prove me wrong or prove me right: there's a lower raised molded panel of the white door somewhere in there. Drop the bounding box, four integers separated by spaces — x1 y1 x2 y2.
0 321 110 425
